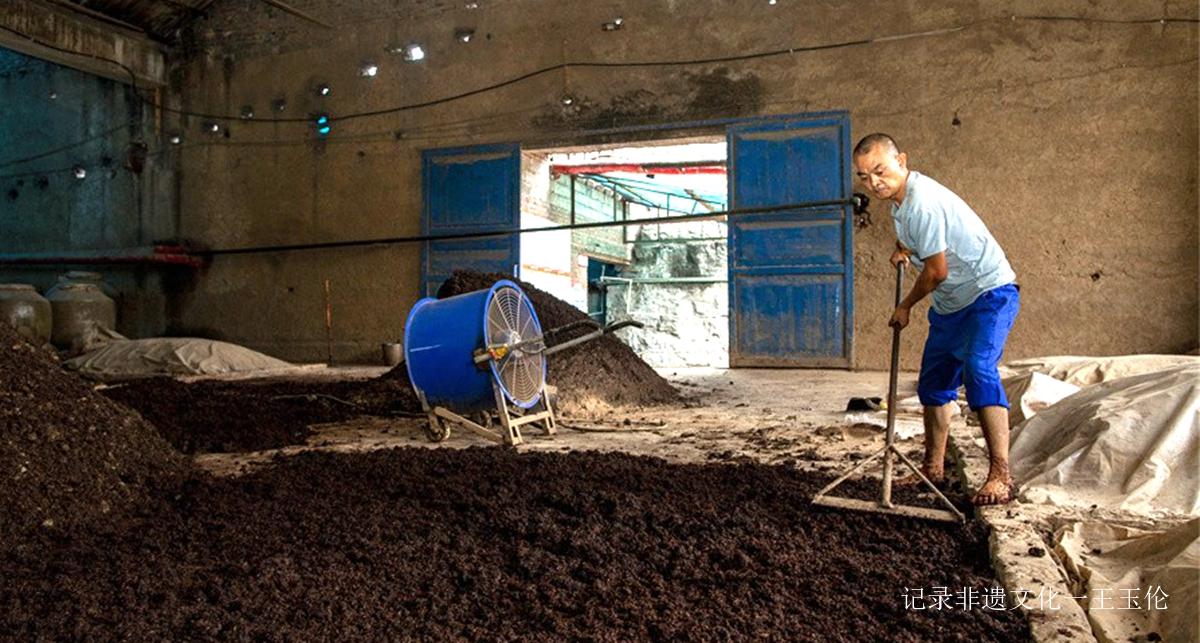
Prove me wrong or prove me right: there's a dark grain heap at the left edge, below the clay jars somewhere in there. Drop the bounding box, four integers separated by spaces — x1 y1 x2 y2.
0 323 185 545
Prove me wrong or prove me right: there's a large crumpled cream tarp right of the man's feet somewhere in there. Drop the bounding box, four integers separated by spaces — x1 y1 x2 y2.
1010 362 1200 515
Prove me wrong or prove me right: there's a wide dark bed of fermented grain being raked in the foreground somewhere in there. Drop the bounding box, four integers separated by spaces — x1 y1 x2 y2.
0 447 1027 641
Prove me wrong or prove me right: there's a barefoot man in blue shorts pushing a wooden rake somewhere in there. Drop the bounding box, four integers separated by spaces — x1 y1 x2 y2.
854 133 1020 505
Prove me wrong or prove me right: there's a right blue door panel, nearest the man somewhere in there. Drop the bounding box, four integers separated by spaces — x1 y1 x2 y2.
728 113 854 367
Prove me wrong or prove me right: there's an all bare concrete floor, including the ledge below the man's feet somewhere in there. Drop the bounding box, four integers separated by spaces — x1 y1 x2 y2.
196 367 1094 642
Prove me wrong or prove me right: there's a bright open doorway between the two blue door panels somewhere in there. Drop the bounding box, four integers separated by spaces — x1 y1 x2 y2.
520 136 730 368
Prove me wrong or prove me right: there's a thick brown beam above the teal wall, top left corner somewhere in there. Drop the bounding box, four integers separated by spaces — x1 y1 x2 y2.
0 0 167 86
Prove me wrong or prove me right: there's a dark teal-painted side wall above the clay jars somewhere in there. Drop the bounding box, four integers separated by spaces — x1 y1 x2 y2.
0 49 177 336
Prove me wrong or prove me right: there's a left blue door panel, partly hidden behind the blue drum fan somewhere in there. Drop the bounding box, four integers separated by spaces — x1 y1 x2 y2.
421 144 521 296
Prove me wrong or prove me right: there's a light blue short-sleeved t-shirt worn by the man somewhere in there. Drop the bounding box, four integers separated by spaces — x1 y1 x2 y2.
892 172 1016 314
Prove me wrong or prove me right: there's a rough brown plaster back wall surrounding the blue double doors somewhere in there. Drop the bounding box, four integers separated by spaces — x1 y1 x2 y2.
176 0 1198 368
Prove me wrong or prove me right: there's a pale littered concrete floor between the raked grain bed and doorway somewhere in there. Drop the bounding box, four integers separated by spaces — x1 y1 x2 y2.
197 367 920 474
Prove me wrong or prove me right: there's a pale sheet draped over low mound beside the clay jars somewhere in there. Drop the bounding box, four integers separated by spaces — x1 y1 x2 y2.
64 337 292 381
